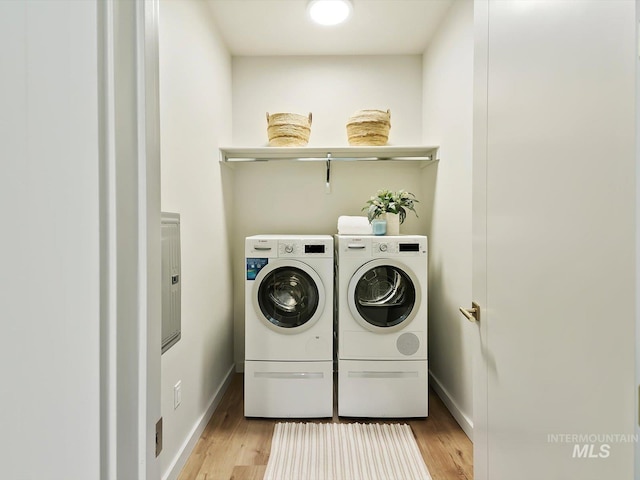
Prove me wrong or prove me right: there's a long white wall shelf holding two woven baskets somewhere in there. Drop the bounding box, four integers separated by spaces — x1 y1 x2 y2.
220 146 438 164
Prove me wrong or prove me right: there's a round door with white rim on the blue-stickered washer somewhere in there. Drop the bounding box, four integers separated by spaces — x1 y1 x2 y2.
253 260 325 333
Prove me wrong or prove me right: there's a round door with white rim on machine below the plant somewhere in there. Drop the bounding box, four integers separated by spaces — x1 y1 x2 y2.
348 258 421 332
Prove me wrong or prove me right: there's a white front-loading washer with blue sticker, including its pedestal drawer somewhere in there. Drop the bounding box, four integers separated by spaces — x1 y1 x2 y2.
244 235 334 418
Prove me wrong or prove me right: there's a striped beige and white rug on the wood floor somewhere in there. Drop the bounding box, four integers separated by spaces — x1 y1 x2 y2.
264 423 431 480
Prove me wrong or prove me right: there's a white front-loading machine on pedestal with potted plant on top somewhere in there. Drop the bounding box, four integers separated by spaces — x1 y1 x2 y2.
335 235 428 418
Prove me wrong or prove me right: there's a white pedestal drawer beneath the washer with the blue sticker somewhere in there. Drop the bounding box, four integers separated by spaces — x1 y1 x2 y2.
244 360 333 418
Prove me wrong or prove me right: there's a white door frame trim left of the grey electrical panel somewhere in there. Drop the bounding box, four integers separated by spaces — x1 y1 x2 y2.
96 0 161 480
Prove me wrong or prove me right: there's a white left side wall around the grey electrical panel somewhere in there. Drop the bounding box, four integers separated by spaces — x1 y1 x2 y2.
160 0 233 478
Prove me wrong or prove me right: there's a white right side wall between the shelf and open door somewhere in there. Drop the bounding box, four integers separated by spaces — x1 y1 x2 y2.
423 0 474 436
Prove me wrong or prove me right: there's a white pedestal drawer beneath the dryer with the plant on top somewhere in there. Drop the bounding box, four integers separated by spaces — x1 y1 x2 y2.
338 360 428 418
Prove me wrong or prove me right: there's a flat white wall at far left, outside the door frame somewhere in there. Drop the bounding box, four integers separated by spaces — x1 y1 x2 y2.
0 1 101 480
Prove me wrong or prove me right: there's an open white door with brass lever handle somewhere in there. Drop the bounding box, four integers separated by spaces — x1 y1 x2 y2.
473 0 638 480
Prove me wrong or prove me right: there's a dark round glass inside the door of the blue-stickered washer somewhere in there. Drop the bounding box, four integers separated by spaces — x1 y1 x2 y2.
254 265 321 329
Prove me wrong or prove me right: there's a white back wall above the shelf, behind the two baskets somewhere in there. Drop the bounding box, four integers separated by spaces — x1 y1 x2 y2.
233 55 422 146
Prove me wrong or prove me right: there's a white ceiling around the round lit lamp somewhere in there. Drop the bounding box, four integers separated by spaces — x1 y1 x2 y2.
207 0 453 56
